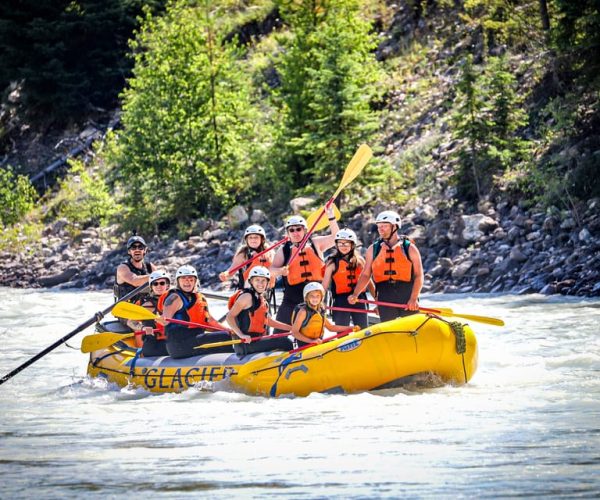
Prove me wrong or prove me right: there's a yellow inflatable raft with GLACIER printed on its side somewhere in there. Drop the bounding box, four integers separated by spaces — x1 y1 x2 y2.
88 314 477 396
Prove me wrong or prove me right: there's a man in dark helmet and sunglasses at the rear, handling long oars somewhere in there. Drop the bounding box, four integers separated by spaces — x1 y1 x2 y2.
114 236 156 302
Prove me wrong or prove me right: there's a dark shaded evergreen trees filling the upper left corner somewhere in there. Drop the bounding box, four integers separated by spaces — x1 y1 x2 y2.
0 0 164 118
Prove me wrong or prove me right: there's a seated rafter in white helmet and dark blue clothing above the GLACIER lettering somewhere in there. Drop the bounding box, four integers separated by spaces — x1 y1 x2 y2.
159 266 231 359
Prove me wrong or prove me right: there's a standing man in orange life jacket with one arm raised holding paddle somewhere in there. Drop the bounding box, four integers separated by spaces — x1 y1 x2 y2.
271 208 340 332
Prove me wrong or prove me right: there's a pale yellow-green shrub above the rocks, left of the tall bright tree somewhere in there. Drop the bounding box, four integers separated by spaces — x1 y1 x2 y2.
46 160 121 232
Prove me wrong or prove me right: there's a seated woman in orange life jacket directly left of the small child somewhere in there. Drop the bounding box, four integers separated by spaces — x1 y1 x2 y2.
226 266 293 357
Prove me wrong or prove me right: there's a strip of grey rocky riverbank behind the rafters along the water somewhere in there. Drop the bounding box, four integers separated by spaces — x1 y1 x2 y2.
0 199 600 296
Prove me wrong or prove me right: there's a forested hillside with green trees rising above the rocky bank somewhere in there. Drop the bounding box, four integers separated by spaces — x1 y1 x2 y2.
0 0 600 292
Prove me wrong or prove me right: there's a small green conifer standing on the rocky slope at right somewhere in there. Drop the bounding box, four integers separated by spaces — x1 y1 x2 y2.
453 56 528 199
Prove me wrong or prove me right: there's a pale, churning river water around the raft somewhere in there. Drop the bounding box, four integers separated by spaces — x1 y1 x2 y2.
0 289 600 498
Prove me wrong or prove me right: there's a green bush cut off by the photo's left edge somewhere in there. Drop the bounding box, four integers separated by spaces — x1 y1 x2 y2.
0 167 37 228
